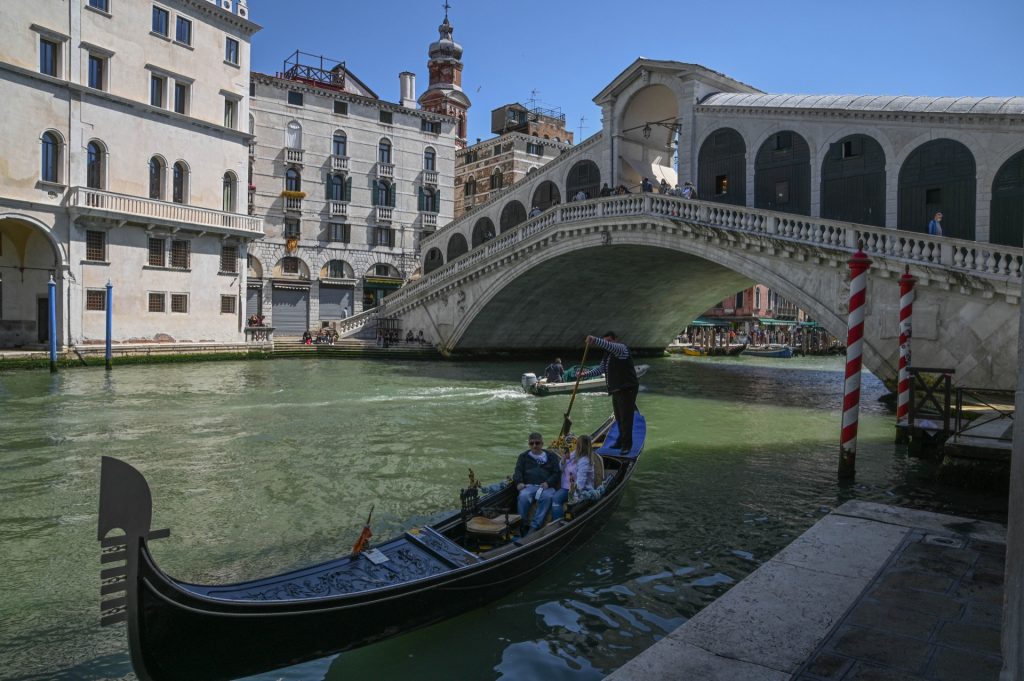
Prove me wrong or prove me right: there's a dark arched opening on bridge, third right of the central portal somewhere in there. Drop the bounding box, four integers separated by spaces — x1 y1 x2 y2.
821 134 884 227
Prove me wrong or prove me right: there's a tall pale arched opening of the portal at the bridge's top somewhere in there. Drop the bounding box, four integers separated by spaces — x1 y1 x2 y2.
618 83 680 196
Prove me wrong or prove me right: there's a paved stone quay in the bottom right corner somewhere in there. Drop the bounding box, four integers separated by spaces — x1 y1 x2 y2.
607 502 1007 681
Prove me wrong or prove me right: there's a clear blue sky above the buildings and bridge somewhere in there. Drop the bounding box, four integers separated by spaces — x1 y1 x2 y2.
249 0 1024 142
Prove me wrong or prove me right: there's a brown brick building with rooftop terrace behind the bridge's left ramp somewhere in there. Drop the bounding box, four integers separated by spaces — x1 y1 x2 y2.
455 103 572 218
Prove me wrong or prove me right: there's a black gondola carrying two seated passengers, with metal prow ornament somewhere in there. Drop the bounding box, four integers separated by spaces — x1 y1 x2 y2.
97 413 646 681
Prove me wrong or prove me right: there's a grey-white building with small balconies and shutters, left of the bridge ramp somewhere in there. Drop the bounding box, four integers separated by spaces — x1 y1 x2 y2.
246 52 459 337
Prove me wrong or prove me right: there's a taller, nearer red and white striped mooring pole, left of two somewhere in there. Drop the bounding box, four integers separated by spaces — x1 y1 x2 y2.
839 248 871 479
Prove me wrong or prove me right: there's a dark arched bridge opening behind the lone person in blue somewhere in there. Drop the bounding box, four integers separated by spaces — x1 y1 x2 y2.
896 139 977 240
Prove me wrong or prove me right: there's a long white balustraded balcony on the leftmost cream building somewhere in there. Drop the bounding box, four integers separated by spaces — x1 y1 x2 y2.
67 186 263 237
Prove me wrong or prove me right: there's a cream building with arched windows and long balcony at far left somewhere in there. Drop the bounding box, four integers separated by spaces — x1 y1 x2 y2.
0 0 262 347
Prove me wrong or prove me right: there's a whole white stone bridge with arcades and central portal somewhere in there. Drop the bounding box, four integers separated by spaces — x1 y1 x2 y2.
335 59 1024 388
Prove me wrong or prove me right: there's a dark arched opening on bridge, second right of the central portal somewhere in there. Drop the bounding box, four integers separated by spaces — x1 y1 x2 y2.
754 130 811 215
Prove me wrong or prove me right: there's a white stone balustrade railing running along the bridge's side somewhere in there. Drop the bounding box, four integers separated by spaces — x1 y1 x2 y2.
383 194 1024 313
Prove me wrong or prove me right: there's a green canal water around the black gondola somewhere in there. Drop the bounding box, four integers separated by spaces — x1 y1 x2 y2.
0 356 1006 681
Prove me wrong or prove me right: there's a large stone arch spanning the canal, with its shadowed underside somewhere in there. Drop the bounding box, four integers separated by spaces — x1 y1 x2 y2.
447 223 847 361
